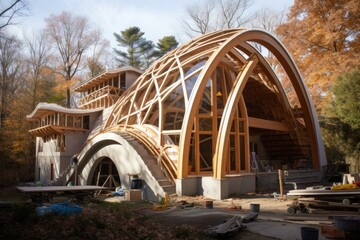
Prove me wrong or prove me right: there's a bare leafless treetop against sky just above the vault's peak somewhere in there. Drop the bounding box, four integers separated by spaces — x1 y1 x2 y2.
182 0 255 38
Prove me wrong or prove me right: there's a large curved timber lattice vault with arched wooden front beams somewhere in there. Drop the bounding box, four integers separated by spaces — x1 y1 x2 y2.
100 29 325 179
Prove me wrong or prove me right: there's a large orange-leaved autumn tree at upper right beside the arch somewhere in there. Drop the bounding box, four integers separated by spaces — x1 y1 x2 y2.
276 0 360 115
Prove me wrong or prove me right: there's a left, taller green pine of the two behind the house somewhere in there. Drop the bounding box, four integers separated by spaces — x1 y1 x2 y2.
114 27 154 69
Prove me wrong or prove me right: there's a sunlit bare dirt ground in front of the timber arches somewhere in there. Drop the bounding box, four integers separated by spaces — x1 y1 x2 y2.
137 194 360 240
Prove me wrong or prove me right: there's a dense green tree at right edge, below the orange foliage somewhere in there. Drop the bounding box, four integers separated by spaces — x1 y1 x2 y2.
320 69 360 172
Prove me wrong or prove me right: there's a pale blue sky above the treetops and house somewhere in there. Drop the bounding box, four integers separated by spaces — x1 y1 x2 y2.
11 0 293 47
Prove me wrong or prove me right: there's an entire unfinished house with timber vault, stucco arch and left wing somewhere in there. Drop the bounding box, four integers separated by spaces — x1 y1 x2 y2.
28 29 326 200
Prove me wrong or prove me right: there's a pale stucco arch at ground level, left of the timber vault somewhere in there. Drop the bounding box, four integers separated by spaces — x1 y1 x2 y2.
74 132 164 201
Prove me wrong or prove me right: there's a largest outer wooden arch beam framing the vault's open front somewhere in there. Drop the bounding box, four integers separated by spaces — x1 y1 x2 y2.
177 30 325 178
